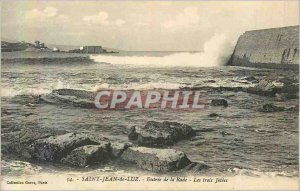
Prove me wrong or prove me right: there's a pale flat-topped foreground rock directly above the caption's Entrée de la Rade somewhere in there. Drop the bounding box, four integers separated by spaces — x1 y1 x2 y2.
121 147 191 172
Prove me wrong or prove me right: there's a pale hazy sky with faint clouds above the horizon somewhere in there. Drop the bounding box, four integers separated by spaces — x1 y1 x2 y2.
1 0 299 50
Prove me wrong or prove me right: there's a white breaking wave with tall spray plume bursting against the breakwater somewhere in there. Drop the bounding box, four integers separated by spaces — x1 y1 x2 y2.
90 34 233 67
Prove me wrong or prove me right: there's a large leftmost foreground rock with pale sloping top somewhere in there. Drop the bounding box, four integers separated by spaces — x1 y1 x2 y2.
30 133 99 161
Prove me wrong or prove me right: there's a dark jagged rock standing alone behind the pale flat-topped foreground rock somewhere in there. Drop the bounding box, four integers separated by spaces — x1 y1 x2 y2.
128 121 195 146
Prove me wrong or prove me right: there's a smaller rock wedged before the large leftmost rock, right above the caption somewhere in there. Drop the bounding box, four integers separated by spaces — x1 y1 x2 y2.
61 142 111 167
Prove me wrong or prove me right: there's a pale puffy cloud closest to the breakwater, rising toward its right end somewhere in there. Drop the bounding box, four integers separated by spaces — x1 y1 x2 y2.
161 7 200 30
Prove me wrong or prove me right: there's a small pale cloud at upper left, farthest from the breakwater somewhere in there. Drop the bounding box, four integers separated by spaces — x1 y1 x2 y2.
25 7 57 19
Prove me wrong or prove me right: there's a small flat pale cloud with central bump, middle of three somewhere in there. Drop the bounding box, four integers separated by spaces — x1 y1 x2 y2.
82 11 125 27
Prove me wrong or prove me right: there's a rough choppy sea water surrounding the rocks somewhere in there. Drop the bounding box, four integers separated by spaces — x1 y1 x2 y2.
1 52 299 177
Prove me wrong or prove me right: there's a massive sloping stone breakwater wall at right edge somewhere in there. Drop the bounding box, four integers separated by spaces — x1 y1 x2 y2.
228 26 299 69
